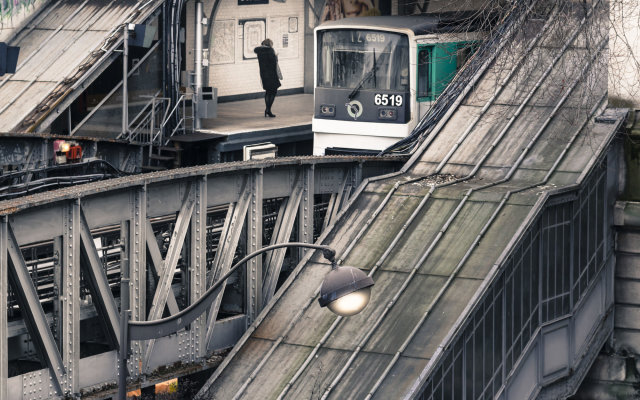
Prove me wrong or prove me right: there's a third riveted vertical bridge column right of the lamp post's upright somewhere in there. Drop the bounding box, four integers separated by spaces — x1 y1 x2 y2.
245 169 264 327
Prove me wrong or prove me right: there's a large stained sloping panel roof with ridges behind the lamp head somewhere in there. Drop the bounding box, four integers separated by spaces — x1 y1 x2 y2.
200 2 626 399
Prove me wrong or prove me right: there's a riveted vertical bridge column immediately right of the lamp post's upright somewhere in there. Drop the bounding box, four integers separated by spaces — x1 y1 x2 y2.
129 186 147 377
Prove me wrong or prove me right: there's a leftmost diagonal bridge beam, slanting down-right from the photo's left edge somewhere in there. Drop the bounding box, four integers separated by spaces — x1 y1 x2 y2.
4 223 66 394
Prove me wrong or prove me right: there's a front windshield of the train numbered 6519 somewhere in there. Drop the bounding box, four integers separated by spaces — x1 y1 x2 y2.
318 29 409 91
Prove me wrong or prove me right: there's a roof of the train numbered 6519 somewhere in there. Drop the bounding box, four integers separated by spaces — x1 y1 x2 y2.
316 12 488 35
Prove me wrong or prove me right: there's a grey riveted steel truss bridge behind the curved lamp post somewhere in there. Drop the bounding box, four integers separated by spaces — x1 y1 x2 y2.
0 157 403 400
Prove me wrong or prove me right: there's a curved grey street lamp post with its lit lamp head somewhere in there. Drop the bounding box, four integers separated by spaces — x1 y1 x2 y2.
118 242 373 400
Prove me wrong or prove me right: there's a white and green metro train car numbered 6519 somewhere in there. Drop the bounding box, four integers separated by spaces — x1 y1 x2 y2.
312 14 483 155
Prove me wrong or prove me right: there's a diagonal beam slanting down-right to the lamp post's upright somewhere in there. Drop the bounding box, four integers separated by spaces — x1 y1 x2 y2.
80 210 120 348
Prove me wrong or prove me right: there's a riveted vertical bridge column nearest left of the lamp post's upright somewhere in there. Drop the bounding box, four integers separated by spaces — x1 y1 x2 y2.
60 199 80 395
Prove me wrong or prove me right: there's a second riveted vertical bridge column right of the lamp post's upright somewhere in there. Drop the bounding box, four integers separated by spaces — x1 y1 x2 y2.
189 176 207 362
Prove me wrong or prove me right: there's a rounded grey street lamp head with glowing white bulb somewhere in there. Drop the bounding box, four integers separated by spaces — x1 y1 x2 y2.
318 266 373 317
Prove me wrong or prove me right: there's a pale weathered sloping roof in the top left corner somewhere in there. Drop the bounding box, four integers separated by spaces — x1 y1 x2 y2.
0 0 162 132
